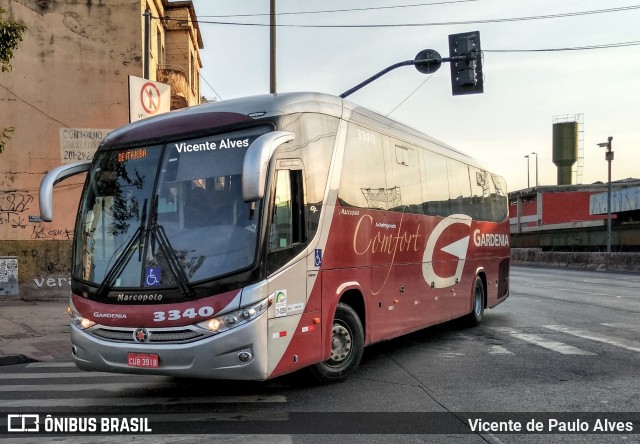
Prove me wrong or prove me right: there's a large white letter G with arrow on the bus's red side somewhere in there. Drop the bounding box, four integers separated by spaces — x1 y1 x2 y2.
422 214 471 288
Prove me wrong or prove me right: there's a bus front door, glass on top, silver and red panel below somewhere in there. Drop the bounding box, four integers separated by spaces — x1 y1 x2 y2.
267 163 321 376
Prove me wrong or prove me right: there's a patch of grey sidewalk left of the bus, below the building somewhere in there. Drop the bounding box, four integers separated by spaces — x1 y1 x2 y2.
0 298 71 365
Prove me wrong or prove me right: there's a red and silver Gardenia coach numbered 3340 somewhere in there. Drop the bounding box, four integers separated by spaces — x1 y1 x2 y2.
40 93 509 381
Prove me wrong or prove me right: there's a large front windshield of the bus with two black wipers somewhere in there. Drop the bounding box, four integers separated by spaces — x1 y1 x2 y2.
72 127 269 296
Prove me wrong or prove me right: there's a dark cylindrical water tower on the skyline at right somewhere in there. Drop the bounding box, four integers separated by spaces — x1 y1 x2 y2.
553 114 584 185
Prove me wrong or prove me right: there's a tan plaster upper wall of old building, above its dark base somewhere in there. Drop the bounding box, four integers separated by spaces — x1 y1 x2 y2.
0 0 142 243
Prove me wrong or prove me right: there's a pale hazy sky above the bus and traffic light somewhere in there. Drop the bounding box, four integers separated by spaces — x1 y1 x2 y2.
185 0 640 191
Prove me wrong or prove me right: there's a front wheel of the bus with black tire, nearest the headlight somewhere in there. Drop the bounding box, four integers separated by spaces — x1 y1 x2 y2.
309 302 364 383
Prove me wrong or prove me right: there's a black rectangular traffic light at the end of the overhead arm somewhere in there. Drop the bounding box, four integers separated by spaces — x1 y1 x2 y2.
449 31 484 96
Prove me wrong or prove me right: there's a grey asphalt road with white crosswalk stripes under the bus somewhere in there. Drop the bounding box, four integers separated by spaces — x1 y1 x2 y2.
0 267 640 443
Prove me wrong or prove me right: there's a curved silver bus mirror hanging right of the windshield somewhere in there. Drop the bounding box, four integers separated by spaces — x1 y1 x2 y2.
242 131 295 202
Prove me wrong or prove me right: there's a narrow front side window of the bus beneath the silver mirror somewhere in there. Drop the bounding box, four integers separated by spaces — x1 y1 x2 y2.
268 170 307 270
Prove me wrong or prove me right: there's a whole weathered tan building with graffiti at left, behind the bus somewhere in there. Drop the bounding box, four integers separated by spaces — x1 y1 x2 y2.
0 0 203 299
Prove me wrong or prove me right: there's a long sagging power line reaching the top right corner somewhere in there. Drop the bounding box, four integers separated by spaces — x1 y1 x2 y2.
164 5 640 29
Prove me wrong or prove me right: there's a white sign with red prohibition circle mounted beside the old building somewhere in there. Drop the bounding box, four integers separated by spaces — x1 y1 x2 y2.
129 76 171 122
